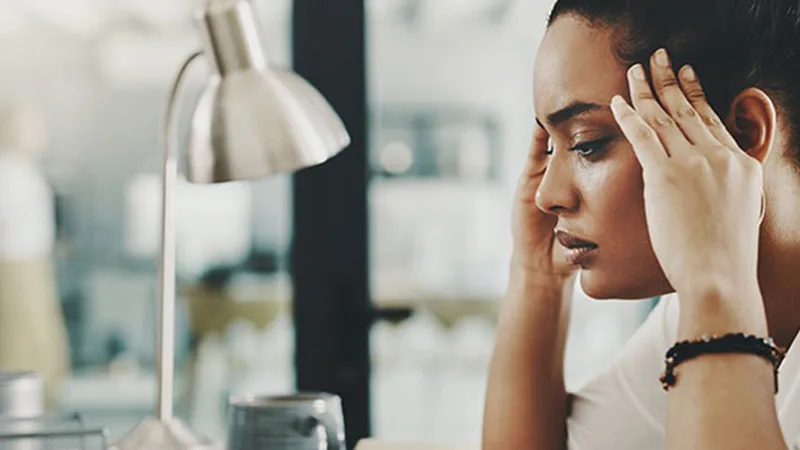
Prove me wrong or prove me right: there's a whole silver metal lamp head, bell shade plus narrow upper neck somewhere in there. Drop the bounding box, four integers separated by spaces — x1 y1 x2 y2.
186 0 350 183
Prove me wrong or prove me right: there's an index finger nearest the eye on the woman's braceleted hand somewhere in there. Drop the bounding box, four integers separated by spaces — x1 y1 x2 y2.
611 95 668 171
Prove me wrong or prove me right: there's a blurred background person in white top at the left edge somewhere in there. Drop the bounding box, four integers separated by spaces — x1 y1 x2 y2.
0 99 69 405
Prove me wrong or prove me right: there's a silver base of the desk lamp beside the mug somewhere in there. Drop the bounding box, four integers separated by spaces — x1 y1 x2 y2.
109 417 224 450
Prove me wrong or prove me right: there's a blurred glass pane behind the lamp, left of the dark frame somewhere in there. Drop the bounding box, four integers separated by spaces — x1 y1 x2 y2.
0 0 294 442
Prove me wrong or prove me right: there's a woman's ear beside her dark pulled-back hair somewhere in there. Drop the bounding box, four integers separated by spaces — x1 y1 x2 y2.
725 88 778 162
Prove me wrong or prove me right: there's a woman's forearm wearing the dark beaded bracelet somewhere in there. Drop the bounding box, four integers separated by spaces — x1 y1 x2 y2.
667 286 786 450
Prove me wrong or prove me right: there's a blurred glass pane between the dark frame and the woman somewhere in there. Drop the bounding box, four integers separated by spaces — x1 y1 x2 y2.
367 0 643 443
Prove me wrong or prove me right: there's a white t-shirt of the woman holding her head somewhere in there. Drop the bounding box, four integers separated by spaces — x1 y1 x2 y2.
567 295 800 450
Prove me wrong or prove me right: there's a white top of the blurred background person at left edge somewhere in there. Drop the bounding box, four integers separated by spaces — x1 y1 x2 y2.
0 154 55 261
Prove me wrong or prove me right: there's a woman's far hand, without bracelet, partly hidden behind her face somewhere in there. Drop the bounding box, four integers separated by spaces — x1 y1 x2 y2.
511 124 577 281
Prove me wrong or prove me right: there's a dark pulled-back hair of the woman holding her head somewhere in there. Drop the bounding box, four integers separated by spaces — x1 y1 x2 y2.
549 0 800 163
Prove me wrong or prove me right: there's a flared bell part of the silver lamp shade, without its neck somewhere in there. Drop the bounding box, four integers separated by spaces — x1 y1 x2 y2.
186 69 350 183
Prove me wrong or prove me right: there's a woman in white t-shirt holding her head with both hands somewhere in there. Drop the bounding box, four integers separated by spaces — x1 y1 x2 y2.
484 0 800 450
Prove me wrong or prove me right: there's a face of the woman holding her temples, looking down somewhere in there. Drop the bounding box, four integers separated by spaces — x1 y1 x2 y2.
534 16 671 299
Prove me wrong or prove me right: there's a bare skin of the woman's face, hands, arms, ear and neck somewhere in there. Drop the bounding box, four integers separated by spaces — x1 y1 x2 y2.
483 16 800 450
